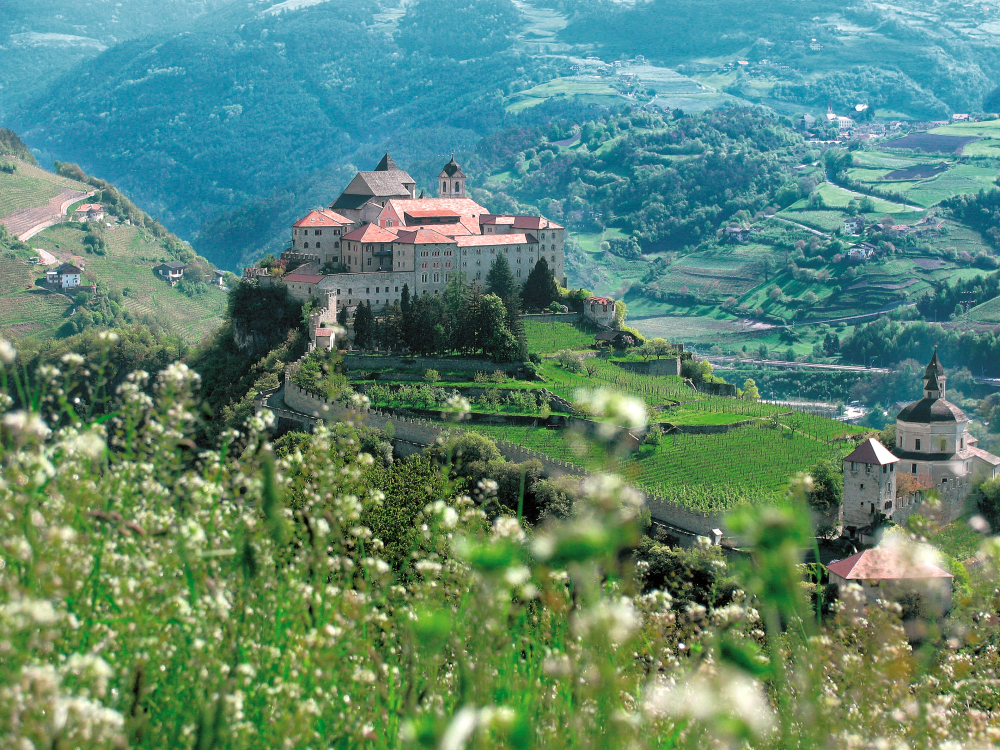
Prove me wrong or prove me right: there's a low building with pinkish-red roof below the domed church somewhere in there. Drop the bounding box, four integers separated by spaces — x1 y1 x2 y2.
826 545 954 615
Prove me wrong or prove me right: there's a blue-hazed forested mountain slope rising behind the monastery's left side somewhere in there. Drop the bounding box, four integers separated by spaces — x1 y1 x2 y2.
9 0 551 265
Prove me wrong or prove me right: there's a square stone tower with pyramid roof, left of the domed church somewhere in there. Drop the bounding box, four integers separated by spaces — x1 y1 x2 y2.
844 438 899 536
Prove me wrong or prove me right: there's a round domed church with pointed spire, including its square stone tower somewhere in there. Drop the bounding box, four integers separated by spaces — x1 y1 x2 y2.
843 347 1000 537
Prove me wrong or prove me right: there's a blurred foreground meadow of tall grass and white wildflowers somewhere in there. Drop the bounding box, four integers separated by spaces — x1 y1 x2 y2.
0 342 1000 750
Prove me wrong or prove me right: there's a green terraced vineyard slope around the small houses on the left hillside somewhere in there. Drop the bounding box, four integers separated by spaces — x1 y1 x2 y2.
32 224 226 343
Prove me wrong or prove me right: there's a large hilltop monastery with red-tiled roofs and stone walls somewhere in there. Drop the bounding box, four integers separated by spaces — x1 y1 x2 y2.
274 153 566 310
